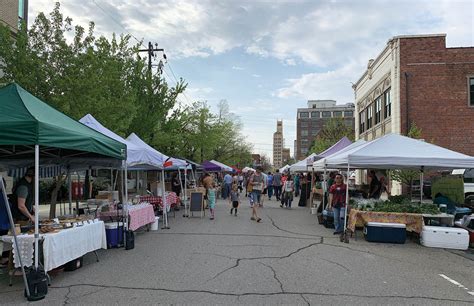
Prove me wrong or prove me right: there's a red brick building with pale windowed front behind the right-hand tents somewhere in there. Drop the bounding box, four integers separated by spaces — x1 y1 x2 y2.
353 34 474 155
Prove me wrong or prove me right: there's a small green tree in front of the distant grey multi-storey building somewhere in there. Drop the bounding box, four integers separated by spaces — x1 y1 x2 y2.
309 118 354 154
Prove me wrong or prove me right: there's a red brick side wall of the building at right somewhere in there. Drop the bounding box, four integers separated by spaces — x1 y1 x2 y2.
400 36 474 155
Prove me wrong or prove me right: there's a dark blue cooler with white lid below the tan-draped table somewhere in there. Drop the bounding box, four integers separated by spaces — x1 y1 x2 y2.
364 222 407 243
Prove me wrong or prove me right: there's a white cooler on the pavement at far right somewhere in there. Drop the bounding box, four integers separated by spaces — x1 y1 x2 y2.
420 226 469 250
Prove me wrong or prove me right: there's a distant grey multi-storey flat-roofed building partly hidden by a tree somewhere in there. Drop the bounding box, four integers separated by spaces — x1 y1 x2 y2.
295 100 354 160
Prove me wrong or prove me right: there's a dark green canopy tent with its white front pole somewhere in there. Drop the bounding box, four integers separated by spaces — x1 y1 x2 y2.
0 83 127 278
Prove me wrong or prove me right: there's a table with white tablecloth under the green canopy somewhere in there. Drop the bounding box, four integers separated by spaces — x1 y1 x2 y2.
2 221 107 272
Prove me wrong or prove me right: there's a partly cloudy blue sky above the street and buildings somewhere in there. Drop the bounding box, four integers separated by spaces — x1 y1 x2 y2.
29 0 474 158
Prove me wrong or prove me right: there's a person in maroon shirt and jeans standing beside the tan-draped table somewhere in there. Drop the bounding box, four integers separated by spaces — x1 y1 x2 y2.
329 174 347 235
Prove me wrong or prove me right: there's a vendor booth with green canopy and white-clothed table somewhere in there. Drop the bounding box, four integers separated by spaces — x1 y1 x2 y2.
0 83 126 300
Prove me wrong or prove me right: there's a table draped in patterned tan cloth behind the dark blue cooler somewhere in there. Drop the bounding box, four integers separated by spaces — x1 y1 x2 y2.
347 209 424 234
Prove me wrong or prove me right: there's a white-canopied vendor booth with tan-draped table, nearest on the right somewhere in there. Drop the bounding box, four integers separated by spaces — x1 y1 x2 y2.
313 134 474 246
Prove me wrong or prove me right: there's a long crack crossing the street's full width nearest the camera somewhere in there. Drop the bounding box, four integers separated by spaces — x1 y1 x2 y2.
50 283 472 303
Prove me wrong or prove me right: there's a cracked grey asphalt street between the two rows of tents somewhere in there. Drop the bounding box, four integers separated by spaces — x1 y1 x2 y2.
0 200 474 305
